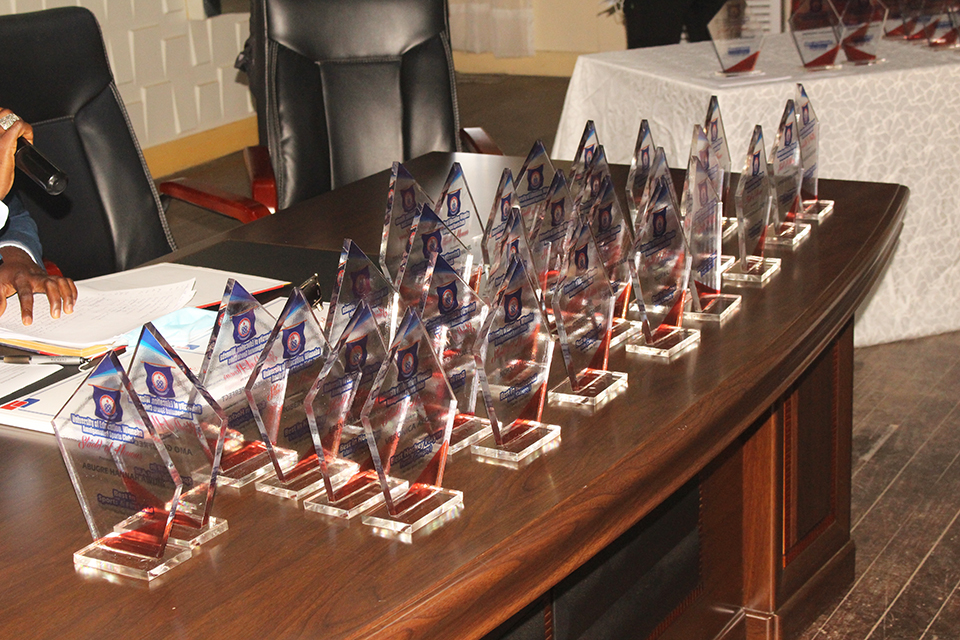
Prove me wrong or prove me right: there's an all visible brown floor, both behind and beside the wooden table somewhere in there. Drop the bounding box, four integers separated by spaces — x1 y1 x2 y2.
156 71 960 640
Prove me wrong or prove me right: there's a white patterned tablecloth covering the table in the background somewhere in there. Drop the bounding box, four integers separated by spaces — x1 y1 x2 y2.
553 34 960 346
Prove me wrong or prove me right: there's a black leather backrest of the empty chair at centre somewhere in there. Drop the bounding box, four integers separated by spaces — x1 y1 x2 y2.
249 0 459 207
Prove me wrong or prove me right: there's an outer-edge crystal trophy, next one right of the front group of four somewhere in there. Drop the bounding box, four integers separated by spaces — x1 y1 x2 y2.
470 258 560 465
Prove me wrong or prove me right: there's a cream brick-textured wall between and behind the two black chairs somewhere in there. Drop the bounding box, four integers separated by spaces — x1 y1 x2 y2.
0 0 254 147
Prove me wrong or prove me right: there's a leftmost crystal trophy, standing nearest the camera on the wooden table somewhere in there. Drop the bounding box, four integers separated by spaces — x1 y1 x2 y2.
53 351 192 580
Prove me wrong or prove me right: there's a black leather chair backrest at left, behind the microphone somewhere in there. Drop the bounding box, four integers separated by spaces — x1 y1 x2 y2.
0 7 175 278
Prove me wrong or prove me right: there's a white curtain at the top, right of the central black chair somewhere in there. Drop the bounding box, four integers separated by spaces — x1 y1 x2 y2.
449 0 534 58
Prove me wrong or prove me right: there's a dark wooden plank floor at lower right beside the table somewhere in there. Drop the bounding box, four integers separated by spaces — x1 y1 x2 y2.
802 333 960 640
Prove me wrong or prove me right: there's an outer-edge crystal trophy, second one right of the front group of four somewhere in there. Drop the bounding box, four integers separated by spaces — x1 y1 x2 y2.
550 220 627 410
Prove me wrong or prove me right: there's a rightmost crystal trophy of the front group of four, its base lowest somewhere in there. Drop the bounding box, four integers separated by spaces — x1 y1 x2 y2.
360 309 463 535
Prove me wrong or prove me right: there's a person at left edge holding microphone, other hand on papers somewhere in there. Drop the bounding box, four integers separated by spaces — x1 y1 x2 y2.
0 108 77 325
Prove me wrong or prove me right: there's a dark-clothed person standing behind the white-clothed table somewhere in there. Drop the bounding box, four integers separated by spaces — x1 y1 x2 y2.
623 0 726 49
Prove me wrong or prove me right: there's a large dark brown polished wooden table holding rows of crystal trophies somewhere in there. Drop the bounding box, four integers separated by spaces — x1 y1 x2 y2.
0 153 908 639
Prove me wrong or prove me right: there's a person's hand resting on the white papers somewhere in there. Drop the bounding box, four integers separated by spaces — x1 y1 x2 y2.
0 246 77 325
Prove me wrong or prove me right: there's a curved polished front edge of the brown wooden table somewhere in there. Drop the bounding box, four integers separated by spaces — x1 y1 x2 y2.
342 181 909 638
